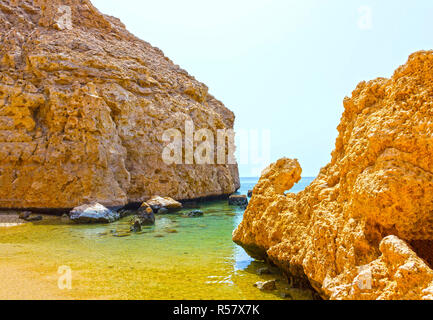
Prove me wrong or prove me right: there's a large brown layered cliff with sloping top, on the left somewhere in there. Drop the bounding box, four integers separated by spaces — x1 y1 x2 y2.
0 0 239 208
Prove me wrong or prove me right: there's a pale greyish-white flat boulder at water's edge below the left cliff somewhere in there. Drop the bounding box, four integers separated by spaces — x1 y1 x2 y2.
69 203 120 224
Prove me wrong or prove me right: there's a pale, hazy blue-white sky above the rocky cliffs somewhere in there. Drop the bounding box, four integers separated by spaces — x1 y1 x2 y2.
92 0 433 176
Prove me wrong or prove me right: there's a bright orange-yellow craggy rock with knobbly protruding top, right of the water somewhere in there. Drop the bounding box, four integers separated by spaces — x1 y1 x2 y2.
233 51 433 299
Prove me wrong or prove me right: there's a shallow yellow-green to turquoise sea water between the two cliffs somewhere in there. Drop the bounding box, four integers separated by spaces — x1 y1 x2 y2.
0 178 312 300
